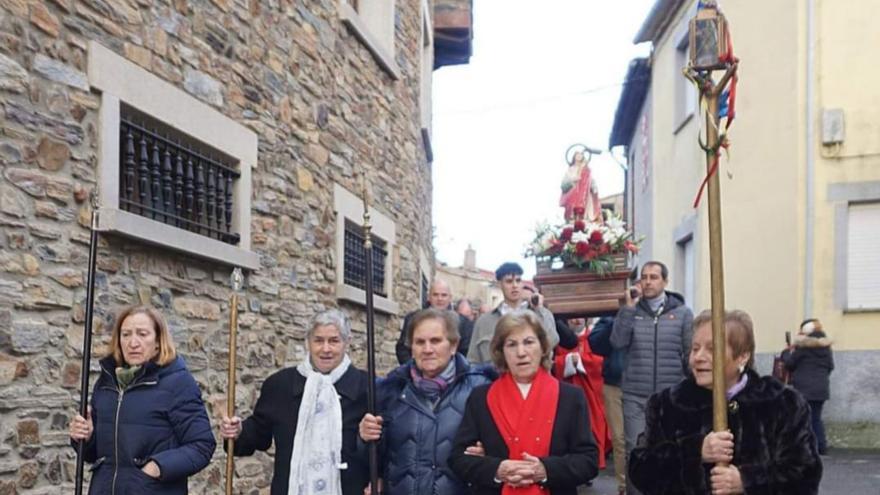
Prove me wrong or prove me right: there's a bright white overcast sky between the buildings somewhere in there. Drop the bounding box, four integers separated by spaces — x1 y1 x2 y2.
432 0 654 278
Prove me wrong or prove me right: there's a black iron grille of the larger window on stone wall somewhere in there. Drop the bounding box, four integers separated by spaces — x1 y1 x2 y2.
119 107 240 244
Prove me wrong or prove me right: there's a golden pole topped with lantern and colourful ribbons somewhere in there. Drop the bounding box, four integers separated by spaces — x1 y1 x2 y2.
684 0 739 442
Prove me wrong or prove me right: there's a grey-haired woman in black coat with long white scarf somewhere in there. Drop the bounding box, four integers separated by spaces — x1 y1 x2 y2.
220 309 369 495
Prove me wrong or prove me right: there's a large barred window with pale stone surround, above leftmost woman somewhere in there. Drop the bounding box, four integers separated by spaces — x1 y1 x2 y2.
88 41 261 270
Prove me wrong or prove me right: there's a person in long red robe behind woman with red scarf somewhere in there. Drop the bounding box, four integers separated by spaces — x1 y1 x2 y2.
553 320 611 469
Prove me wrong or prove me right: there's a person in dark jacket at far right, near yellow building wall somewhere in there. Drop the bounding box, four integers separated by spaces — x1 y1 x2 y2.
782 318 834 455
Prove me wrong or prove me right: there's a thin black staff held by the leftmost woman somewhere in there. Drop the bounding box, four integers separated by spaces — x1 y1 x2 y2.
74 191 99 495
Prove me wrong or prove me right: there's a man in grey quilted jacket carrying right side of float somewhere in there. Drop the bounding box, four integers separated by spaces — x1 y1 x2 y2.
611 261 694 494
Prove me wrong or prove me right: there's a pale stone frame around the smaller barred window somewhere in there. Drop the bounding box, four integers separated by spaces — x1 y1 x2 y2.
333 183 400 315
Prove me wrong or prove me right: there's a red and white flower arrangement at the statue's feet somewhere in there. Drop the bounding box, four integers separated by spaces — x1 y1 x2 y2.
525 210 639 275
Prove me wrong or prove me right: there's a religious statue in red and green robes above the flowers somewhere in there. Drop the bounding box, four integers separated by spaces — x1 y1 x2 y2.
559 144 603 223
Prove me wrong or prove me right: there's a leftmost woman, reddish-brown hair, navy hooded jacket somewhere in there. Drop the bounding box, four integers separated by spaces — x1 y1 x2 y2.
70 306 216 495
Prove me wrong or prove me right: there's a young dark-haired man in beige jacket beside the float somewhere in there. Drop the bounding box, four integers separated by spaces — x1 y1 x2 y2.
467 262 559 364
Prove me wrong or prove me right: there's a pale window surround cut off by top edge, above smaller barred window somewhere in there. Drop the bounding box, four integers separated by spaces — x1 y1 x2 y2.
338 0 402 80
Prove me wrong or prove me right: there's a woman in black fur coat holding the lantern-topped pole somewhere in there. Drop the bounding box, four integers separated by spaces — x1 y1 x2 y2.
628 311 822 495
